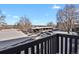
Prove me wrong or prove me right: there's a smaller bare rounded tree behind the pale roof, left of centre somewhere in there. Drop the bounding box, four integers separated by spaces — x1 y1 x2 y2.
16 16 31 31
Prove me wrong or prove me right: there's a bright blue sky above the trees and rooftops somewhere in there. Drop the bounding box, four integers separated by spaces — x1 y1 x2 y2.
0 4 64 25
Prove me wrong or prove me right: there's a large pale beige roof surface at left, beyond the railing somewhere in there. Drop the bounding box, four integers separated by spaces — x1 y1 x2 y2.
0 29 27 41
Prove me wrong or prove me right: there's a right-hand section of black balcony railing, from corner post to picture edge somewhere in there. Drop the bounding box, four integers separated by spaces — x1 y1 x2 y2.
57 34 79 54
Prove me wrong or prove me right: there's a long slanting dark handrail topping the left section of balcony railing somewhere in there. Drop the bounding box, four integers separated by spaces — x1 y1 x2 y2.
0 34 56 52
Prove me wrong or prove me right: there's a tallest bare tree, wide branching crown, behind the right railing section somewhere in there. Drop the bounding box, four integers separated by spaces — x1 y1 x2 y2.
57 4 77 33
